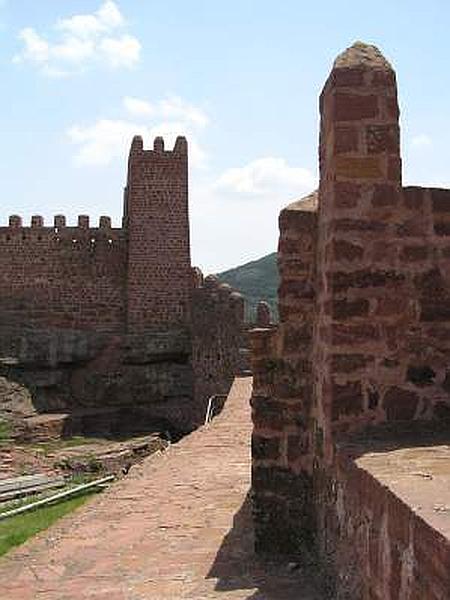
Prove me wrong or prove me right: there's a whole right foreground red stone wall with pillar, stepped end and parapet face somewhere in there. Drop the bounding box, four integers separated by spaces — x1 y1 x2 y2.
252 44 450 600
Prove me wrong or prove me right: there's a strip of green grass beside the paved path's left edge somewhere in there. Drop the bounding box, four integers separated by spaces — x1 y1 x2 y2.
0 492 95 556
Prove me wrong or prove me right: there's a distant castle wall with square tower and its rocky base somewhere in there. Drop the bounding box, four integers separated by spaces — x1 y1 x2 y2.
0 137 243 432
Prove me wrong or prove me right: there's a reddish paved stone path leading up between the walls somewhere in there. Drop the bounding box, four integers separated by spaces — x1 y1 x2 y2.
0 378 322 600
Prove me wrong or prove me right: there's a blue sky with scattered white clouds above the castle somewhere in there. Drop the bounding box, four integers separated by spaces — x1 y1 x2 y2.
0 0 450 272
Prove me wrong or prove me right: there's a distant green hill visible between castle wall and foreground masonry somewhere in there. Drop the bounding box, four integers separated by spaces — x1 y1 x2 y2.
217 252 279 321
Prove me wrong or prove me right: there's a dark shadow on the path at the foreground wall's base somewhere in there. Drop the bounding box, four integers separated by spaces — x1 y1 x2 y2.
207 492 333 600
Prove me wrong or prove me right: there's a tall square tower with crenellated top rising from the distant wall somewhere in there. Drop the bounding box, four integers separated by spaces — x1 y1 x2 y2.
124 137 192 333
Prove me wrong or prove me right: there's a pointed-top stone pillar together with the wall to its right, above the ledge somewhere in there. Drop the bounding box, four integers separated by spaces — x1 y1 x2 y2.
314 42 450 452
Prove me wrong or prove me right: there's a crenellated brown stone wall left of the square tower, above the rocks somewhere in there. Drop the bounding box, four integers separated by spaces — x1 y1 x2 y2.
0 216 127 332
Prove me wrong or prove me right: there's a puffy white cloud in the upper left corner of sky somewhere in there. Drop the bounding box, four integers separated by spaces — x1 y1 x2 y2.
13 0 141 76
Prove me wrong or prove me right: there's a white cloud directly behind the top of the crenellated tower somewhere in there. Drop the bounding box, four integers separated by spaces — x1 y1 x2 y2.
67 96 208 167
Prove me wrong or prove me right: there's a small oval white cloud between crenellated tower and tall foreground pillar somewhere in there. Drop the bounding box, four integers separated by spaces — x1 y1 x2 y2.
215 156 317 196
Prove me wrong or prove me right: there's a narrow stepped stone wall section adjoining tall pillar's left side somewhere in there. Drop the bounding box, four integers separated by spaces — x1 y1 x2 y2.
251 194 317 551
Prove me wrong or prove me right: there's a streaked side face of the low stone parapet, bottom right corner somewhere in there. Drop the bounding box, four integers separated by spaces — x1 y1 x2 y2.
315 438 450 600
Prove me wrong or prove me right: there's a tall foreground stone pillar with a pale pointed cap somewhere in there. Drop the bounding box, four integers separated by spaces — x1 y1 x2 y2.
314 43 402 460
